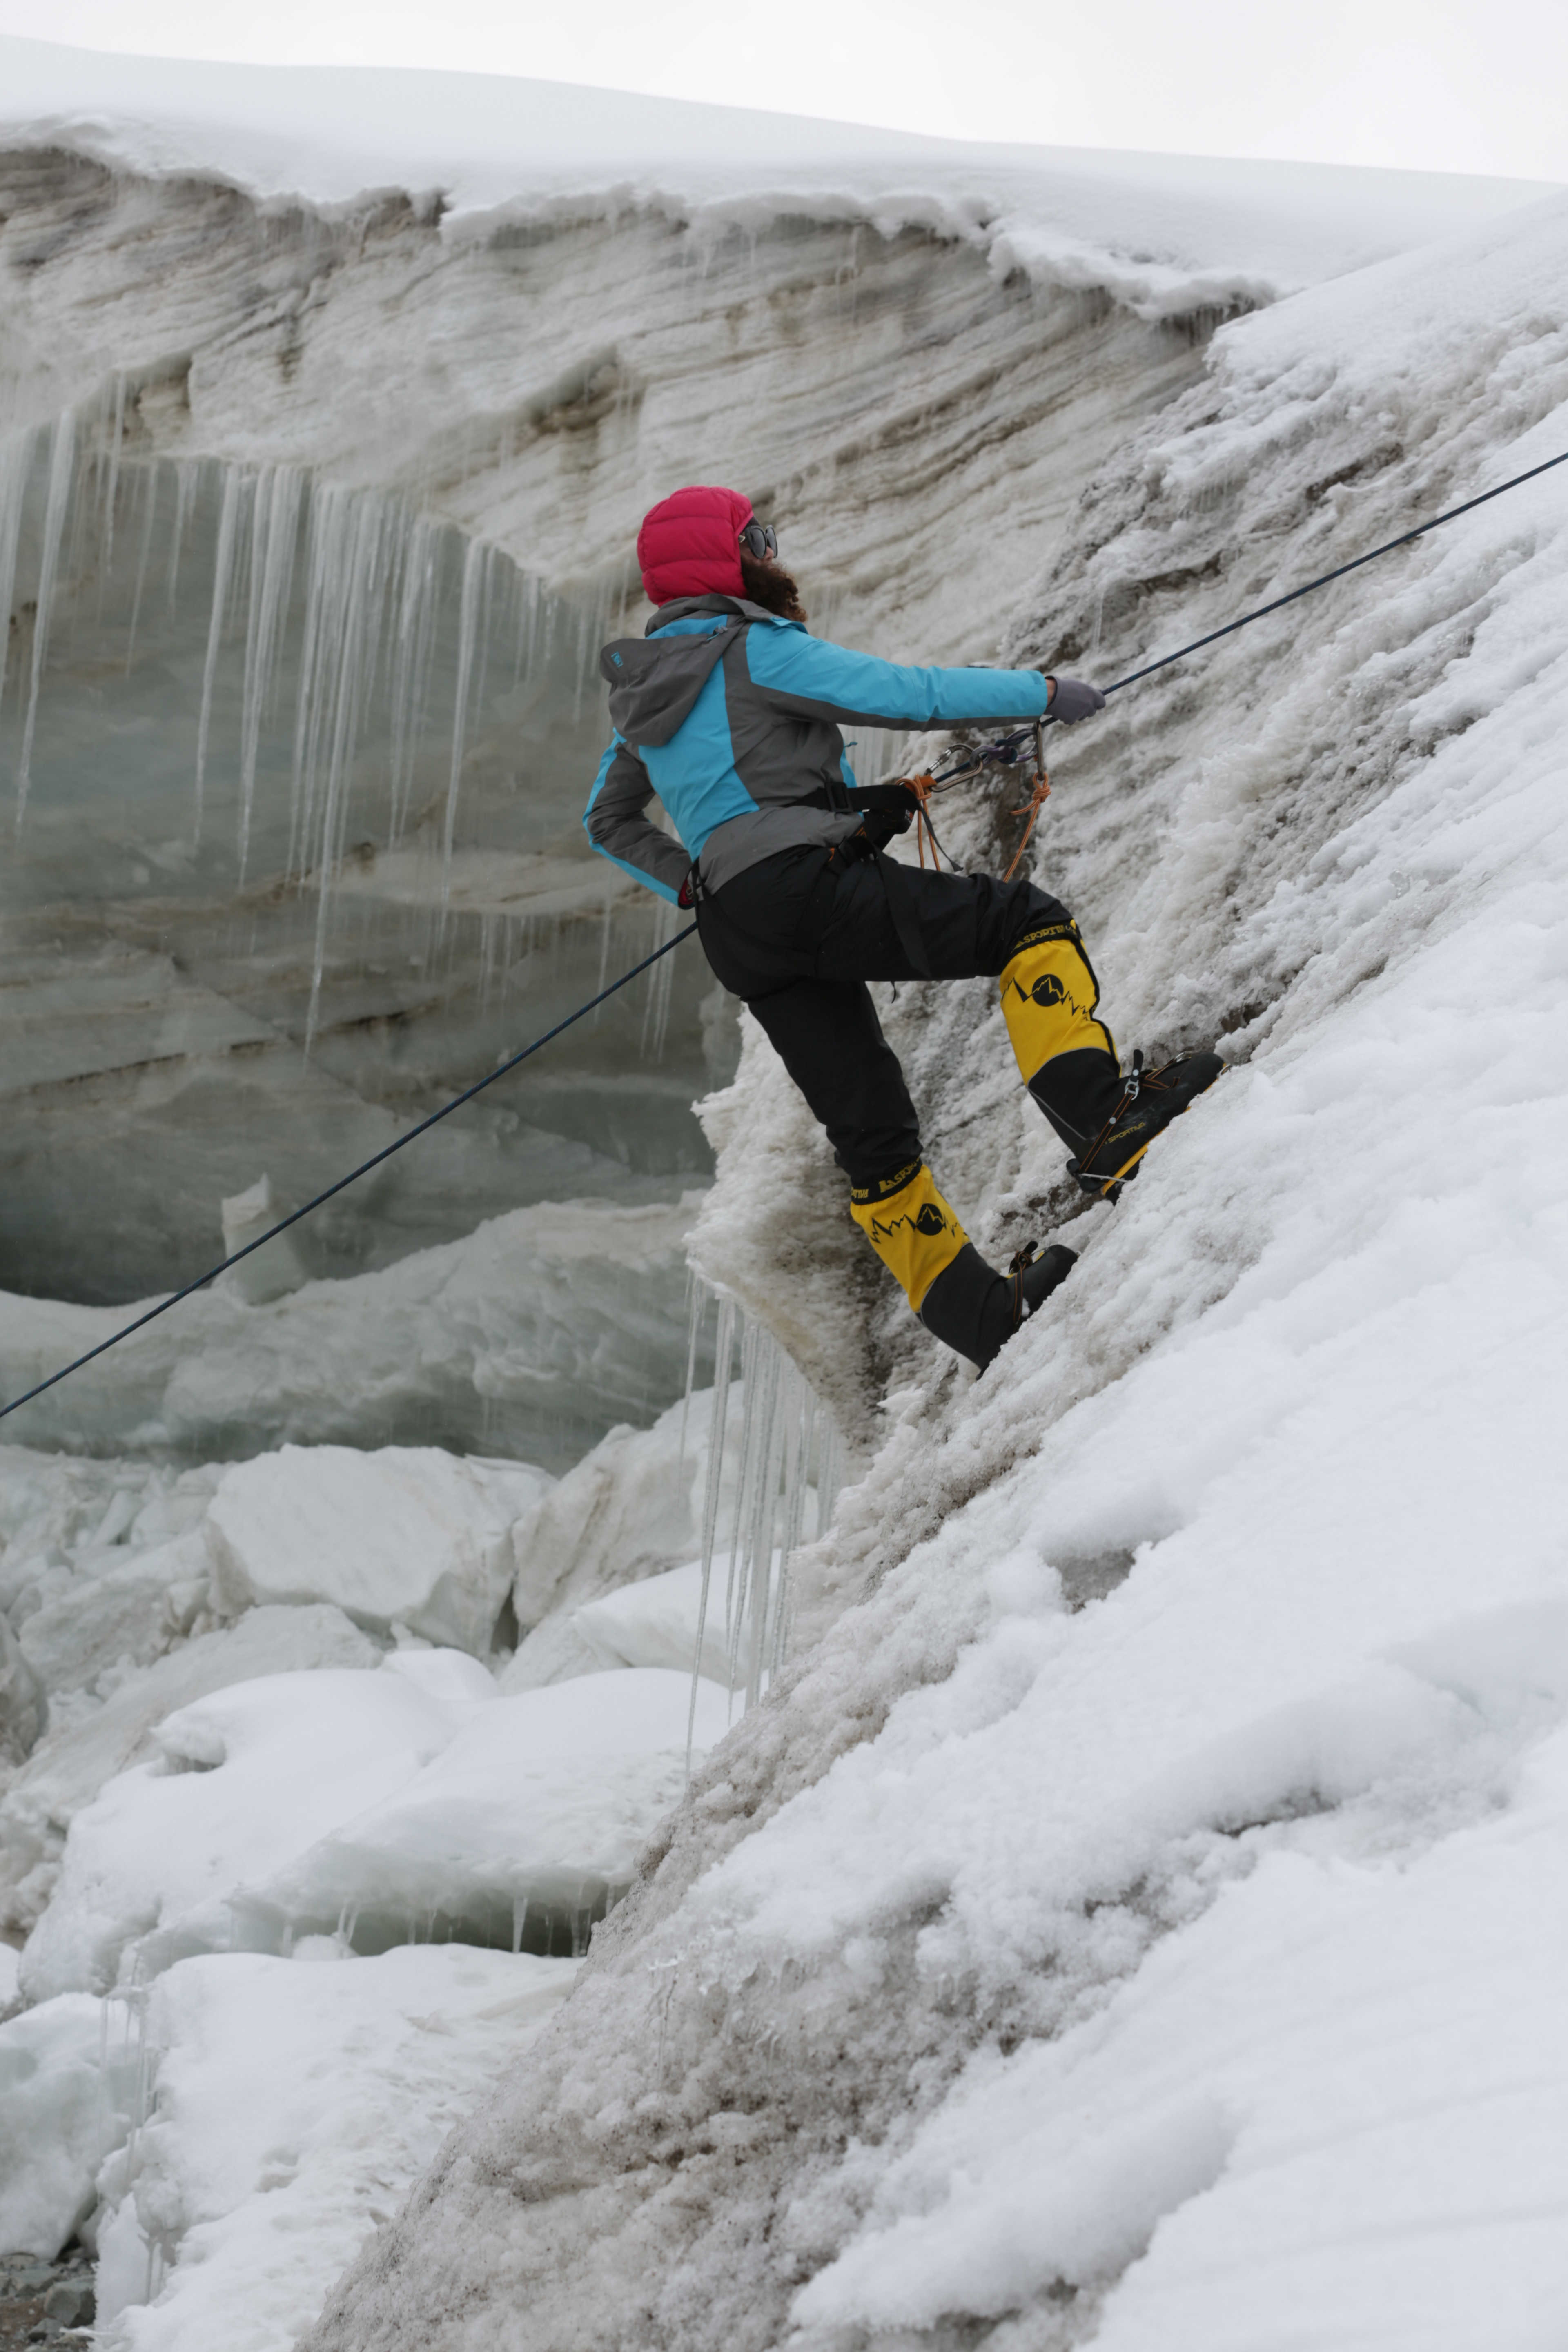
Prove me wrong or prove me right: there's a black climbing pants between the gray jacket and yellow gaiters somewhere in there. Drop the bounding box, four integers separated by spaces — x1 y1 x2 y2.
698 844 1069 1188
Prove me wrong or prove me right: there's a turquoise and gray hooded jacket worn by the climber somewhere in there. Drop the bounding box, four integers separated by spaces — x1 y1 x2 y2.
583 595 1051 898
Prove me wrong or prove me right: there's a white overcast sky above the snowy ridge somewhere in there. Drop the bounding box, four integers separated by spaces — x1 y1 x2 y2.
0 0 1568 181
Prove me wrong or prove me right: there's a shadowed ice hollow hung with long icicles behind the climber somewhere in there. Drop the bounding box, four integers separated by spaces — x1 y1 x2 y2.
0 414 733 1303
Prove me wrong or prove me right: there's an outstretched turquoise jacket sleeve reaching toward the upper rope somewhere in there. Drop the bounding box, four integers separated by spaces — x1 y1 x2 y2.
745 628 1051 727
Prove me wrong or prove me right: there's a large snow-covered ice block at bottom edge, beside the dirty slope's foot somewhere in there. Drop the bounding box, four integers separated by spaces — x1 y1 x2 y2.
87 1943 574 2352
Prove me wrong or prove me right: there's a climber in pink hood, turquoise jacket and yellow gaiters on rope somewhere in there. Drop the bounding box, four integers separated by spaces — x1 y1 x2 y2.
583 489 1220 1367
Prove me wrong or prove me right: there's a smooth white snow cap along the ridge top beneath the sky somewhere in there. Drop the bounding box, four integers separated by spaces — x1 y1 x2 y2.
0 40 1544 318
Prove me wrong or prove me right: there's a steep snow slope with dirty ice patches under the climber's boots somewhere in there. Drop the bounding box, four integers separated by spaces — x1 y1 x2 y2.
308 202 1568 2352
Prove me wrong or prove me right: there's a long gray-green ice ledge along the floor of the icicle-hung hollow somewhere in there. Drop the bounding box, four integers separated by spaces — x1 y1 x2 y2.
0 1200 691 1477
